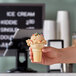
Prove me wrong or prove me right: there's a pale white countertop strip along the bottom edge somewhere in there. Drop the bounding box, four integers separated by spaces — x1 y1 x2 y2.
0 73 76 76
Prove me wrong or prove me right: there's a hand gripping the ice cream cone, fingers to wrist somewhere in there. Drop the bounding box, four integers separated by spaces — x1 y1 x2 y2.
29 47 60 65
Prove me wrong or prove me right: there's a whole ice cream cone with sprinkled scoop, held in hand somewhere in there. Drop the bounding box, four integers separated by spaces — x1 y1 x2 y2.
26 33 46 62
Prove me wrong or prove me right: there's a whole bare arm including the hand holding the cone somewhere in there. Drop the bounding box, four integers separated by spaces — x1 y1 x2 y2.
30 47 76 65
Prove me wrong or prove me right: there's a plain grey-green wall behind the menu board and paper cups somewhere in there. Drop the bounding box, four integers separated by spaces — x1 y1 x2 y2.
0 0 76 73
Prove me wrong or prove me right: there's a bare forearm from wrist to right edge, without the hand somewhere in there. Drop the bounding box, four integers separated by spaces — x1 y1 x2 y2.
58 47 76 63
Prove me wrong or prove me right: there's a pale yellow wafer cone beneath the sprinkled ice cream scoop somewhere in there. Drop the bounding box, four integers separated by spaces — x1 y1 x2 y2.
31 44 44 62
